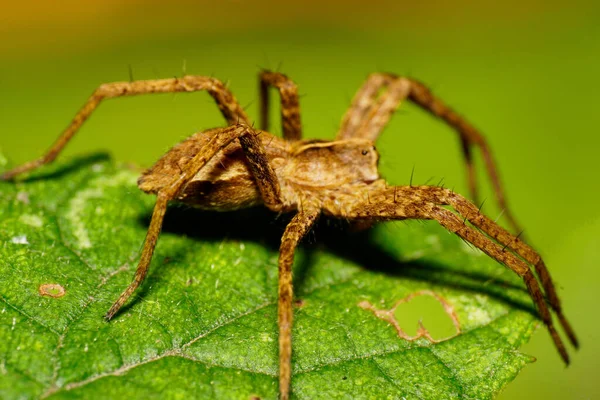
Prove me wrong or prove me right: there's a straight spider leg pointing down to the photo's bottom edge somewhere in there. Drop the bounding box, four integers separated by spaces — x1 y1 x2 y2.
278 209 320 400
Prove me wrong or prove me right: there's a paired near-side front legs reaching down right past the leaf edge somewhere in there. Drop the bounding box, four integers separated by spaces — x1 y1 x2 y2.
340 186 578 364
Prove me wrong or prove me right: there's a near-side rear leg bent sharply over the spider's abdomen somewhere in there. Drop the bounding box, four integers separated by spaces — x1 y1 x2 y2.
105 125 281 320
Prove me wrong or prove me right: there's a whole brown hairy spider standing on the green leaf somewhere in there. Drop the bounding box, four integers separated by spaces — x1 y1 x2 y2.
1 71 578 399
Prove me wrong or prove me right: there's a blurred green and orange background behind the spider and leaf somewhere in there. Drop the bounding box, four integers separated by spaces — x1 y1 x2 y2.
0 0 600 399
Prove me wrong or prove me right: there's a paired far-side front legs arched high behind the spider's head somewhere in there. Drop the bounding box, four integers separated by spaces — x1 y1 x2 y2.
337 73 522 236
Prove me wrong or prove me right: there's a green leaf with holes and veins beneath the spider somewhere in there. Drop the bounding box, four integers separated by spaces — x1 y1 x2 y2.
0 155 537 399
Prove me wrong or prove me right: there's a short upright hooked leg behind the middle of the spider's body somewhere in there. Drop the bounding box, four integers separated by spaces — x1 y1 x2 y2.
259 71 302 140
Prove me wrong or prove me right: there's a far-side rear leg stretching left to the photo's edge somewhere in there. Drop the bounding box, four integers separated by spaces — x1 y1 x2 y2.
0 76 250 180
